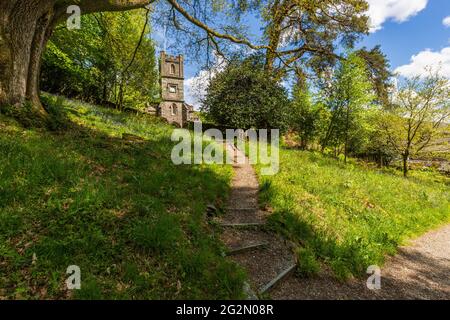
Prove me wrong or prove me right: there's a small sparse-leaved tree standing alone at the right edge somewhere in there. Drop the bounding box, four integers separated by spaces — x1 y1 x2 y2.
379 70 450 177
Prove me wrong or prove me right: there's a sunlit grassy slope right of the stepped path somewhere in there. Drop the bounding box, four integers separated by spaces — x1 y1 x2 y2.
261 149 450 278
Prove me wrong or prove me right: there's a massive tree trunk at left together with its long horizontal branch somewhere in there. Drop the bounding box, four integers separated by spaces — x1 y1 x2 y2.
0 0 153 116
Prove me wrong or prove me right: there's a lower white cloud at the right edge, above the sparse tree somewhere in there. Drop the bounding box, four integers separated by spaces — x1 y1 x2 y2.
395 47 450 78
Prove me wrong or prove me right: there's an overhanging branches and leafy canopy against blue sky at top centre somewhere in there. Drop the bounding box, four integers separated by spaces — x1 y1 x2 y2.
158 0 369 78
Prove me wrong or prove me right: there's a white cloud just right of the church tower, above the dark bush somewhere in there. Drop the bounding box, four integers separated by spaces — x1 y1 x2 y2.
184 55 226 109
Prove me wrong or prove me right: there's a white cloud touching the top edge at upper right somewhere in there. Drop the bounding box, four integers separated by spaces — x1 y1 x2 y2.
367 0 428 32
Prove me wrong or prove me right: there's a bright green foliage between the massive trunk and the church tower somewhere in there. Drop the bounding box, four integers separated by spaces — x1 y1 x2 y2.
41 10 158 108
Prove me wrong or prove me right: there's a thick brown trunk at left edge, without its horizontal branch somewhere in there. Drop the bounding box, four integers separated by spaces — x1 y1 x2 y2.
0 0 54 115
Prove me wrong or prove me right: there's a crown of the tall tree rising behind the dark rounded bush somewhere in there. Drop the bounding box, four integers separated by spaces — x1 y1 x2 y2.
213 0 369 78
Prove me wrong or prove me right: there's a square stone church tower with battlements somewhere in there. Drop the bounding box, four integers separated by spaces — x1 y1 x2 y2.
157 51 193 127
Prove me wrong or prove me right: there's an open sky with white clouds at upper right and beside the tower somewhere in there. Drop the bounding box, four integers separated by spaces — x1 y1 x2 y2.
156 0 450 105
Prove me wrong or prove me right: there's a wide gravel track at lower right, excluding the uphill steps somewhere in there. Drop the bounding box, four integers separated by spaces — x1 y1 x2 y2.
272 225 450 300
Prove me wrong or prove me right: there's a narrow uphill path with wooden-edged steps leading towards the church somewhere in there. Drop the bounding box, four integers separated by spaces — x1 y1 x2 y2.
220 143 295 296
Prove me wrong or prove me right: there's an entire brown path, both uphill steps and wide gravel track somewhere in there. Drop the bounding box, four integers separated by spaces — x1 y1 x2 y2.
220 143 450 299
